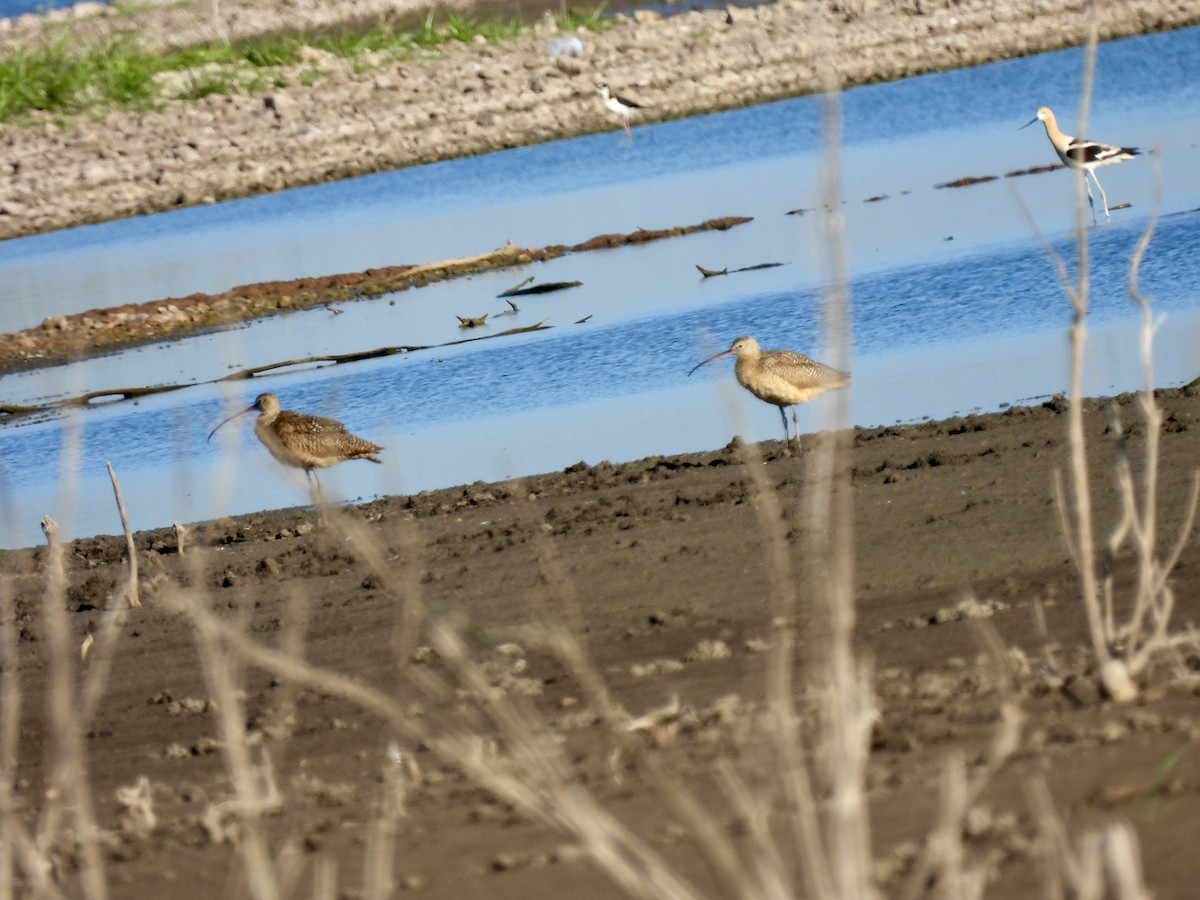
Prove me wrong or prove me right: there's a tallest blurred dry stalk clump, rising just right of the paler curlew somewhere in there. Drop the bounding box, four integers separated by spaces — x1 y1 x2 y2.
676 12 877 900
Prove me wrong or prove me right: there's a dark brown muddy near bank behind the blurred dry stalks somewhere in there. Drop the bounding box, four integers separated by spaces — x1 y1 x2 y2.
0 388 1200 900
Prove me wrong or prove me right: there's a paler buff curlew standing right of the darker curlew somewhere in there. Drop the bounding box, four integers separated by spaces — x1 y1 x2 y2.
688 337 850 443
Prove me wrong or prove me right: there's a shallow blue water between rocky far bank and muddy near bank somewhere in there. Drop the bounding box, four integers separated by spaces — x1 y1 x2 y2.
0 29 1200 545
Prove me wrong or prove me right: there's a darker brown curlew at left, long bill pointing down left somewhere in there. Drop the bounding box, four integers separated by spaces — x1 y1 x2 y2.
209 394 383 494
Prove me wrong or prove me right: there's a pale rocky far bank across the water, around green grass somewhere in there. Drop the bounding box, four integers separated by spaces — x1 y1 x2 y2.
0 0 1200 239
